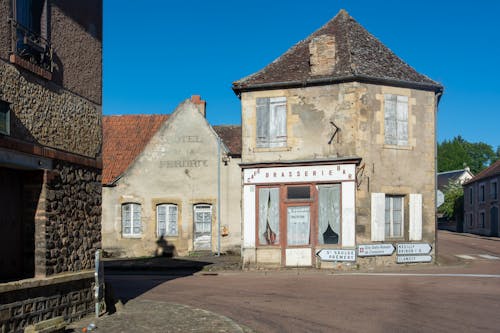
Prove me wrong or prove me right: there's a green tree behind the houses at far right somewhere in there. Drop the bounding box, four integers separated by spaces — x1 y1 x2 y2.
437 135 500 174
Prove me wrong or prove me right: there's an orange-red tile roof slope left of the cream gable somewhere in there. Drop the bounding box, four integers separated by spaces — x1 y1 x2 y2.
102 115 169 184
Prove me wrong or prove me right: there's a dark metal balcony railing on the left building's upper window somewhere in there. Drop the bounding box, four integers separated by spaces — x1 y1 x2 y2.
10 19 53 74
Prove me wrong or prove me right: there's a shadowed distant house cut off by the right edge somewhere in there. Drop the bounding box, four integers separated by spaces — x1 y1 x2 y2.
463 160 500 236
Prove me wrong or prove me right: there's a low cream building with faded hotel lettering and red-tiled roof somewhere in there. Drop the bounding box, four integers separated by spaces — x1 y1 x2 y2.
102 96 241 257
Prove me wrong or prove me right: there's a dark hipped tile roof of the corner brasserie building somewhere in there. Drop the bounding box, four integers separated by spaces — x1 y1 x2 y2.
233 10 443 94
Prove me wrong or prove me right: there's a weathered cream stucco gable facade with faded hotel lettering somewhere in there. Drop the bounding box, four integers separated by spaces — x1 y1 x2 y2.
103 100 241 257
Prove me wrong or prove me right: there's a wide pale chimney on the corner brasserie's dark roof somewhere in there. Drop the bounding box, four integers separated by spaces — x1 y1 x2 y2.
309 35 335 75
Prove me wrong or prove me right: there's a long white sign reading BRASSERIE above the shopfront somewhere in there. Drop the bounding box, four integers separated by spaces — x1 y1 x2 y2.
243 164 356 184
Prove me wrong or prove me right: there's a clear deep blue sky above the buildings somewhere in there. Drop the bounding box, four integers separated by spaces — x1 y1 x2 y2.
103 0 500 148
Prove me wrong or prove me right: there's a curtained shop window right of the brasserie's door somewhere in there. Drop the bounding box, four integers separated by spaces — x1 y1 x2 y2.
318 184 340 244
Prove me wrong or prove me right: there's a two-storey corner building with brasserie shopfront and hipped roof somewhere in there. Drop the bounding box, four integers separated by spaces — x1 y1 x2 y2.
233 11 443 267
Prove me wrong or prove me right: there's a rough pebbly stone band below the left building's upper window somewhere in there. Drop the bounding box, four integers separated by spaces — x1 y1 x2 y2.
0 60 102 158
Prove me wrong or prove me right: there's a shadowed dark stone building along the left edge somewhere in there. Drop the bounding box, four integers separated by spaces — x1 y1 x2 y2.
0 0 102 332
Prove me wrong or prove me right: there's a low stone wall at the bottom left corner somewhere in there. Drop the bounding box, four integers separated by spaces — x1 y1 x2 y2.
0 272 95 332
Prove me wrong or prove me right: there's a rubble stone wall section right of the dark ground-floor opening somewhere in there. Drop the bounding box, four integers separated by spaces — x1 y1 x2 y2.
45 161 102 275
